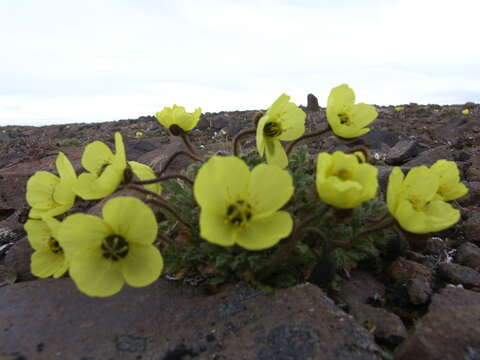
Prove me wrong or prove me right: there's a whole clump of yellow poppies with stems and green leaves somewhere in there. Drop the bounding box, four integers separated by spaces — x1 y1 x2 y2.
25 84 468 297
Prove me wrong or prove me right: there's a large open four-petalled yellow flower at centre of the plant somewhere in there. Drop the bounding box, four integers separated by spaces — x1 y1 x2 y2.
193 156 293 250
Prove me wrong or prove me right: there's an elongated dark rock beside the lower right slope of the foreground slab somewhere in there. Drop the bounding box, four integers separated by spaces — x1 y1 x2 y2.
349 303 407 346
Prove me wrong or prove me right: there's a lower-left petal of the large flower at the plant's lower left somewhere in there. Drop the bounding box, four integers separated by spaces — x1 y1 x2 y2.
69 247 125 297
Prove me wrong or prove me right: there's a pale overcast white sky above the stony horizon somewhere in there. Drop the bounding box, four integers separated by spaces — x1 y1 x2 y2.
0 0 480 125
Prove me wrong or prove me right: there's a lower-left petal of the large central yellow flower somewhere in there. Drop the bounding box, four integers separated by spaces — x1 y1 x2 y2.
200 208 236 246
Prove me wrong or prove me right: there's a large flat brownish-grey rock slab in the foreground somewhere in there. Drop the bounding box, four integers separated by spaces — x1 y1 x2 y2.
0 278 381 360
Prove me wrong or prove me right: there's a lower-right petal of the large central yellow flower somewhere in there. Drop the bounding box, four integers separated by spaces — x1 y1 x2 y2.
234 211 293 250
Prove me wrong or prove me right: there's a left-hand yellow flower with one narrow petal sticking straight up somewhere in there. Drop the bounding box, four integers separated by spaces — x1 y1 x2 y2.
73 132 127 200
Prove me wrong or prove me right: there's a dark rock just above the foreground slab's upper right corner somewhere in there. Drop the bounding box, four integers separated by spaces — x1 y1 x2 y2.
337 270 385 306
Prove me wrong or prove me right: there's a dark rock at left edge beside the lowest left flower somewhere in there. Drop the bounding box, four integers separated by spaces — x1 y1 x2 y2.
4 237 36 281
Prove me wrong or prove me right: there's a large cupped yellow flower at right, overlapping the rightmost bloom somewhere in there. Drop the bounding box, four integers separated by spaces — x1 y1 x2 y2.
387 166 460 234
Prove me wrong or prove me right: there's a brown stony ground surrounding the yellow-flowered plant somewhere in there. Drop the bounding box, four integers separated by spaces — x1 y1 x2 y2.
0 97 480 360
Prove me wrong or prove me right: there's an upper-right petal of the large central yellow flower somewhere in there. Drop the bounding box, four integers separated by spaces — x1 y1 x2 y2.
248 164 293 217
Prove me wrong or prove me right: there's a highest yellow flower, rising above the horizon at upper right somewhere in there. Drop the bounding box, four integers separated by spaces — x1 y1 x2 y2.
327 84 377 139
